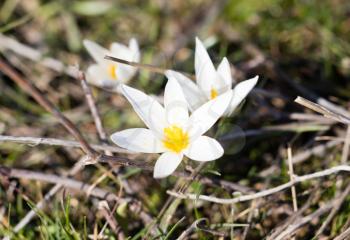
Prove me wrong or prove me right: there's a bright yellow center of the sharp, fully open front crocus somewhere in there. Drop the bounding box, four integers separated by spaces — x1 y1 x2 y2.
163 125 189 153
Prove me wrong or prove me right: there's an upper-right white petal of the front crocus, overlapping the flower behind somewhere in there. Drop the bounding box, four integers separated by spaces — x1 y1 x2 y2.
189 90 232 140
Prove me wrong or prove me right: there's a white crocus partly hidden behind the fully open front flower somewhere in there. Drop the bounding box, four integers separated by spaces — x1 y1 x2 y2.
165 38 258 116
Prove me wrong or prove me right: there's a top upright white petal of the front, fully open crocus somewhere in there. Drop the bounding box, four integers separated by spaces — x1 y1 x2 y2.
164 77 189 126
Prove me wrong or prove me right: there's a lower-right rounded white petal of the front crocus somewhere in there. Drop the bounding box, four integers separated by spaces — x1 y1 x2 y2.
184 136 224 162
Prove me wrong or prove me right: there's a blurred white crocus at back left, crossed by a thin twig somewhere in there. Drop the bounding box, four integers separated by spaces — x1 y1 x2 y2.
83 38 140 90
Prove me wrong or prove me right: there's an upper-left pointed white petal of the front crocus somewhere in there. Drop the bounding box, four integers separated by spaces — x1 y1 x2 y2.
120 84 167 136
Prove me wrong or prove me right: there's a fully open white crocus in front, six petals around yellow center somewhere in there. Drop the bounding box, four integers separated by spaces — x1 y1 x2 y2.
111 77 232 178
